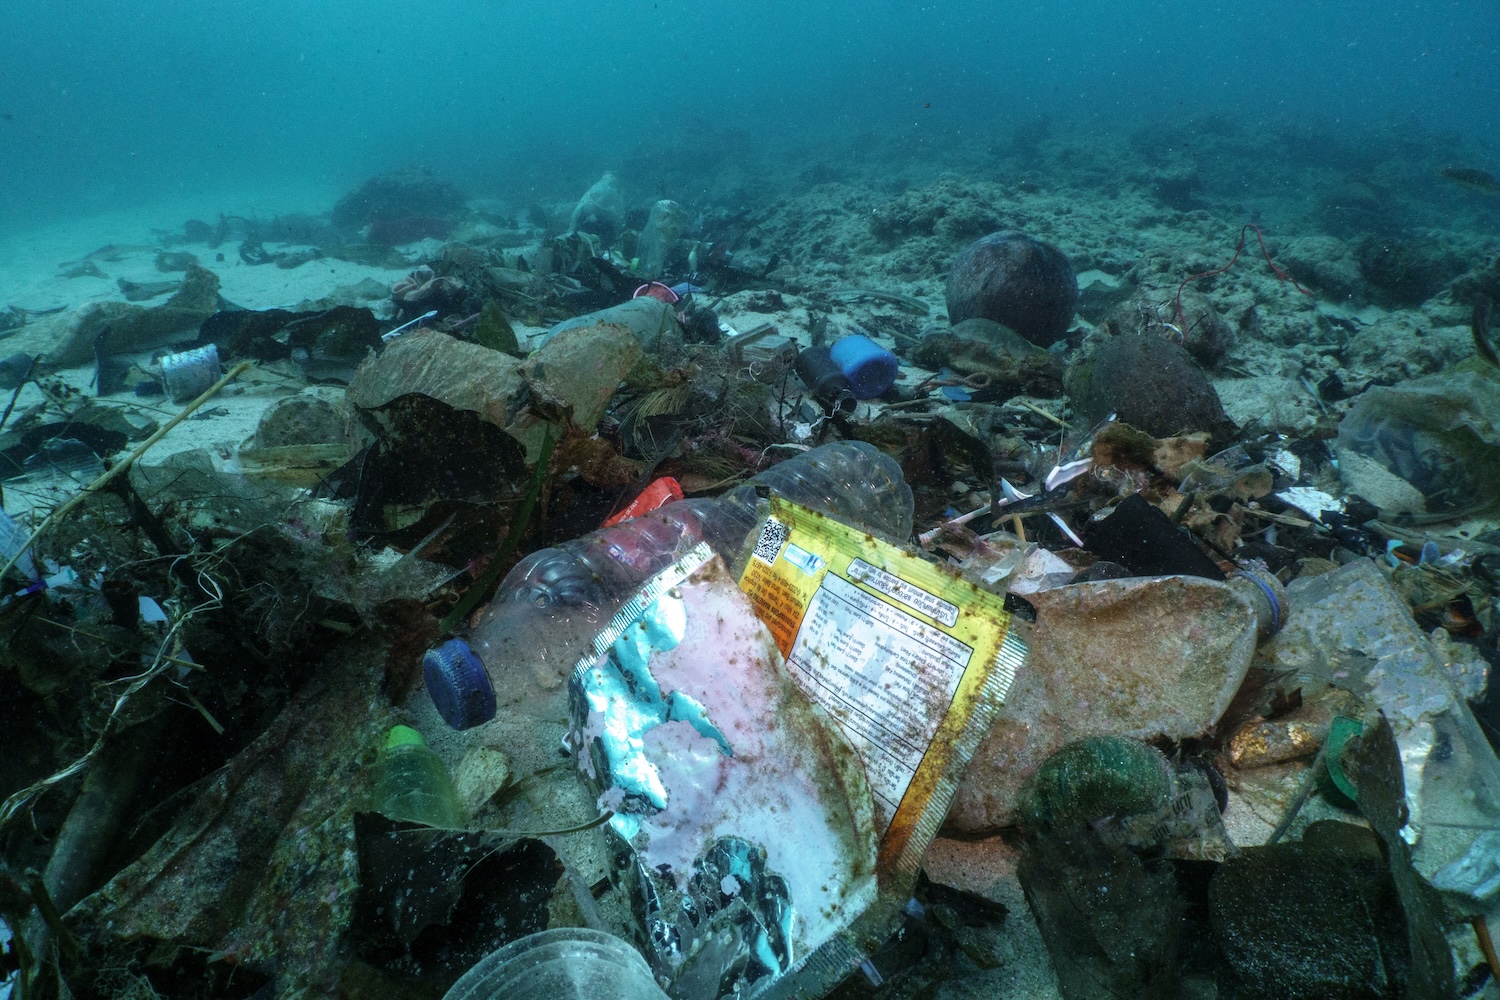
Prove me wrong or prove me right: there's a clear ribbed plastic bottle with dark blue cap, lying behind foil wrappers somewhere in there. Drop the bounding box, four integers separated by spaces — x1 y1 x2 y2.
423 441 912 729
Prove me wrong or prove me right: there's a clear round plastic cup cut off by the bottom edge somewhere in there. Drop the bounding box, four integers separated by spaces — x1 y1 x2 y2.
444 927 668 1000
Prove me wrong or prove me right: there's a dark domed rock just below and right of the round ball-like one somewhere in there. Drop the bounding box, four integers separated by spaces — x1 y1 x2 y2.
1064 333 1233 438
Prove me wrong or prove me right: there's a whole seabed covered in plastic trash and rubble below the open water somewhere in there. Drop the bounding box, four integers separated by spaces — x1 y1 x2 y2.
0 163 1500 1000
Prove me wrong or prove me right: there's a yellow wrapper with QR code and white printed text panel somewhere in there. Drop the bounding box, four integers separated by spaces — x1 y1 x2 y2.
740 496 1026 903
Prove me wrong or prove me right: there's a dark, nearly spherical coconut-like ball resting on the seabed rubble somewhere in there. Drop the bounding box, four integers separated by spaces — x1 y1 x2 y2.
948 231 1079 346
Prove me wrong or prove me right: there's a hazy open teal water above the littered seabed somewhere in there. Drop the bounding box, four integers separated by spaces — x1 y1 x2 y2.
0 0 1500 226
